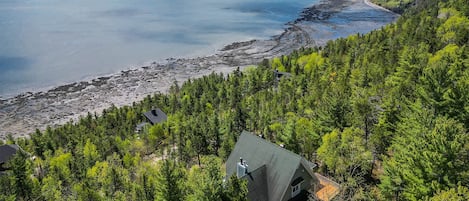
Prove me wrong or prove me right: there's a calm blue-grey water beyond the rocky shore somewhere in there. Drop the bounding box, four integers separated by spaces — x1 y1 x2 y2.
0 0 317 97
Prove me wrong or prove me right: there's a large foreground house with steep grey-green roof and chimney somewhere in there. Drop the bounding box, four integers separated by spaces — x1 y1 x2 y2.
225 131 338 201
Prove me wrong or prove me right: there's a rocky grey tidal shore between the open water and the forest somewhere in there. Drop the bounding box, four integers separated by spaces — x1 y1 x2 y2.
0 0 397 139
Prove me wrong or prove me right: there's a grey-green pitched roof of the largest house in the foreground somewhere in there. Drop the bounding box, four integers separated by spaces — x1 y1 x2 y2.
226 131 313 200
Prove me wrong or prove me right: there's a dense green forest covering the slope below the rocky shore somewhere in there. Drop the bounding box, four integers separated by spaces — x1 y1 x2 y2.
0 0 469 201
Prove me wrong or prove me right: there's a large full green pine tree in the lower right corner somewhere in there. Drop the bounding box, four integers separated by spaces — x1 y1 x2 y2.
380 111 469 200
